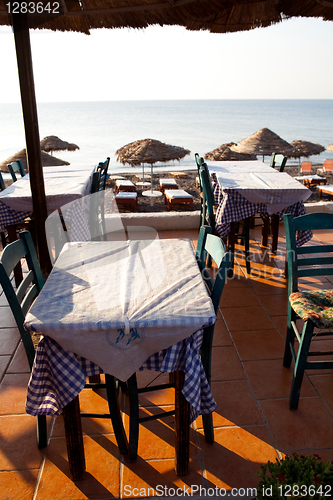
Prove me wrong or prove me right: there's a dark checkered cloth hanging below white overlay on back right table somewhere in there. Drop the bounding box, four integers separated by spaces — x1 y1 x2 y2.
211 173 312 246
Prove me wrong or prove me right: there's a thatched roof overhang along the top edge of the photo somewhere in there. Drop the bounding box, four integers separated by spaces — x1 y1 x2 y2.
0 0 333 34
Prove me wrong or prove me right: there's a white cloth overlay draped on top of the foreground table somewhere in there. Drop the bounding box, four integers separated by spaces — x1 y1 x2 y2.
25 240 215 380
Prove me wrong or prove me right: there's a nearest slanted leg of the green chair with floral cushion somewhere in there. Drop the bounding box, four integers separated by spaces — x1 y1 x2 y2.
289 321 314 410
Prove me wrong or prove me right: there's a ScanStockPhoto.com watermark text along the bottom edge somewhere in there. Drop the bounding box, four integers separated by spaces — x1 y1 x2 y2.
123 484 257 498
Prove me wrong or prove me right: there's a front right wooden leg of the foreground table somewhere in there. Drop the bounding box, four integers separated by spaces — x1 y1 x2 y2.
175 370 190 476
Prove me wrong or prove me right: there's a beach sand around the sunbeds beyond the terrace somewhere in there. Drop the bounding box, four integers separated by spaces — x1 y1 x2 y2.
105 165 333 213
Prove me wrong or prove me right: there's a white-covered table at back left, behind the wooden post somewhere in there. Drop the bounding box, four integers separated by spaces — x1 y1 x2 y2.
0 165 95 231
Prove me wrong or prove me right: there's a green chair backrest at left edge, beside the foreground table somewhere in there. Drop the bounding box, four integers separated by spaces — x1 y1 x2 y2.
0 231 44 368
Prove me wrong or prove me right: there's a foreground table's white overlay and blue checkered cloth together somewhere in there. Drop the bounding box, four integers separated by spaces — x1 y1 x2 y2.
25 239 216 478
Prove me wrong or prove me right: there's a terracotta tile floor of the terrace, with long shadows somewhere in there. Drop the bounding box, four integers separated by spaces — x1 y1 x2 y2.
0 225 333 500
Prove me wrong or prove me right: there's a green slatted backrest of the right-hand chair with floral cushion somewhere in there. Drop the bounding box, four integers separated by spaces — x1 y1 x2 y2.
283 212 333 294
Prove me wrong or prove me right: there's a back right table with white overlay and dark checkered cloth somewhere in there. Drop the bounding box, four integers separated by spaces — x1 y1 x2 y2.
207 161 312 251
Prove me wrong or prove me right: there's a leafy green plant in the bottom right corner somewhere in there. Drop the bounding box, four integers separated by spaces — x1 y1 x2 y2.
257 453 333 500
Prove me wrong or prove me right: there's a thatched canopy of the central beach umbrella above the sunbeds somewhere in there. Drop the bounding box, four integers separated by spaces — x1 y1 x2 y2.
116 139 191 166
